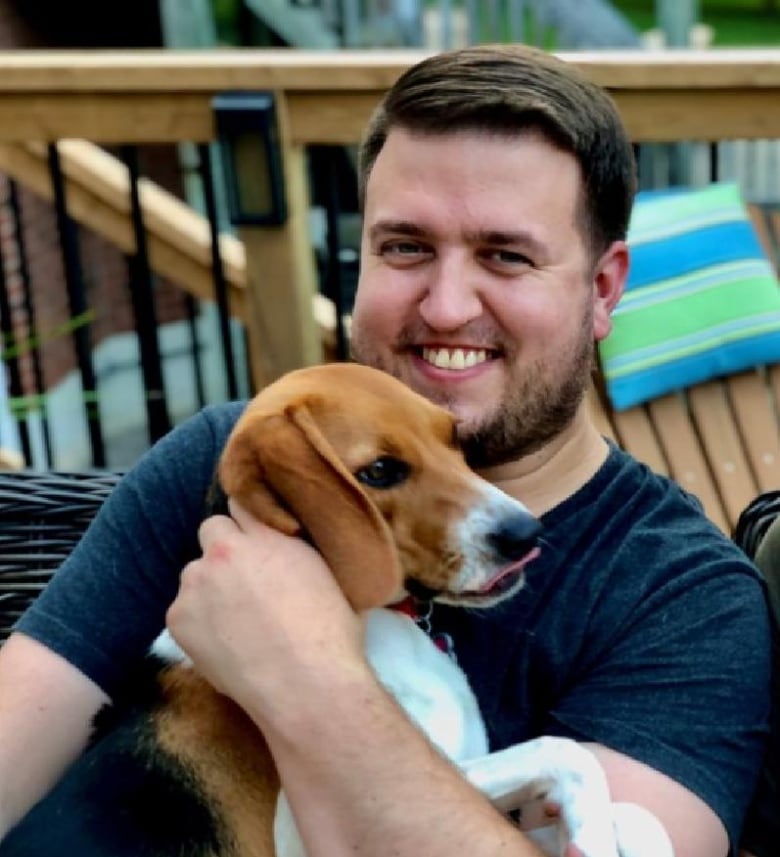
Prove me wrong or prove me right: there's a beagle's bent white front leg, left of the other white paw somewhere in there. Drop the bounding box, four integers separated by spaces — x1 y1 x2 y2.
460 737 619 857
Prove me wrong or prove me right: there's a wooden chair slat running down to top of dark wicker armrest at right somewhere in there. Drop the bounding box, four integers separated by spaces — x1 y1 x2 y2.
688 381 758 528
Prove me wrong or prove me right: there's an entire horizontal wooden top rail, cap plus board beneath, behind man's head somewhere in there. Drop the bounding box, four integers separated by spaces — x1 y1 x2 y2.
0 49 780 143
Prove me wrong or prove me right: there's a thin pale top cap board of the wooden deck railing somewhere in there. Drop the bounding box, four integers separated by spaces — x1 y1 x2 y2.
0 48 780 93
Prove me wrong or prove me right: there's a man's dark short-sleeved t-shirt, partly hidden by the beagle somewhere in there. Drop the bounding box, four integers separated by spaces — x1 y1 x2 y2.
18 404 770 843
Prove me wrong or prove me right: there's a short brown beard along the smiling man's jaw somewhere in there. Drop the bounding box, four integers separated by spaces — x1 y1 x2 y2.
352 307 595 469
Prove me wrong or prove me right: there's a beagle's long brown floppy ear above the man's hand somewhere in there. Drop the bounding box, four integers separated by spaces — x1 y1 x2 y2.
219 404 401 610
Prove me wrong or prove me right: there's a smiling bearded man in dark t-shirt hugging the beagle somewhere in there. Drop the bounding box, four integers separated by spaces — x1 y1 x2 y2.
0 47 769 857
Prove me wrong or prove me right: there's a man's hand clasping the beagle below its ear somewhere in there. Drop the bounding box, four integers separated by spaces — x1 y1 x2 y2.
167 502 368 723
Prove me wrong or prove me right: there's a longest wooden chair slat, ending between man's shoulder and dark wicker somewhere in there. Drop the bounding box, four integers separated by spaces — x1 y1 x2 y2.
647 394 730 533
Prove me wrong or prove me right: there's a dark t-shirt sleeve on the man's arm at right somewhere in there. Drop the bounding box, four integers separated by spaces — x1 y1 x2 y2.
550 546 771 853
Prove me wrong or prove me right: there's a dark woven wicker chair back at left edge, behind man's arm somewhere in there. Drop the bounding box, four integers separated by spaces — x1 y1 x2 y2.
0 470 119 641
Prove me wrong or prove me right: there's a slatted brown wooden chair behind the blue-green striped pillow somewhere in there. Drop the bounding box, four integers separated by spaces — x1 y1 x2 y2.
589 206 780 534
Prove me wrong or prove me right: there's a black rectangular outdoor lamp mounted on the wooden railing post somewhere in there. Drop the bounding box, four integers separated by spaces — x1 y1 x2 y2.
212 92 287 226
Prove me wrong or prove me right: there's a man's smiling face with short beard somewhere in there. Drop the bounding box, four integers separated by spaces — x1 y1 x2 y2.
352 129 624 466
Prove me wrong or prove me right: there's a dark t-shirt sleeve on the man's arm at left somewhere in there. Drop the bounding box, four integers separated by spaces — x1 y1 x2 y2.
16 403 241 695
